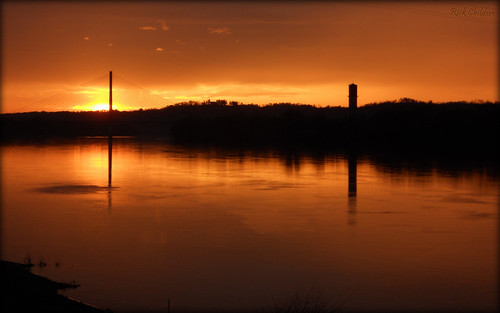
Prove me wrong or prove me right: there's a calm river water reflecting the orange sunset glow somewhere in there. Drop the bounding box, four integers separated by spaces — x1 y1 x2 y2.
2 138 499 312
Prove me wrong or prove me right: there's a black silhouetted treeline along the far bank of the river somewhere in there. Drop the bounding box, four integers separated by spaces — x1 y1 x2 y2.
0 98 500 154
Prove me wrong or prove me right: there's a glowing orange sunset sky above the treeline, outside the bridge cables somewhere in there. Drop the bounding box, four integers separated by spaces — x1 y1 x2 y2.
2 1 499 112
